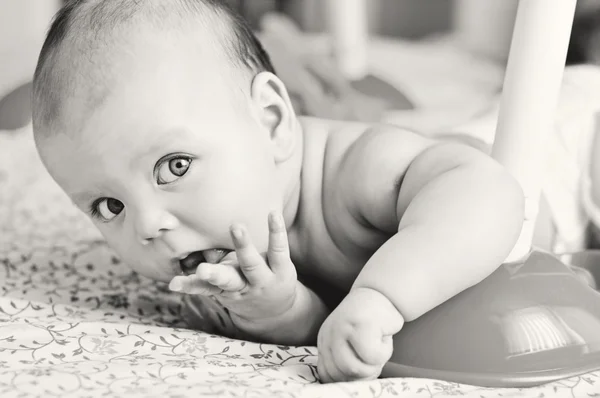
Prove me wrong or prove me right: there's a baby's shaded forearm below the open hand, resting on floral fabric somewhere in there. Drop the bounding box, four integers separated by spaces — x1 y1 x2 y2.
231 282 329 346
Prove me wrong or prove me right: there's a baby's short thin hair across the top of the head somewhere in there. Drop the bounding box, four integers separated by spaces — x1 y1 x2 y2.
32 0 275 131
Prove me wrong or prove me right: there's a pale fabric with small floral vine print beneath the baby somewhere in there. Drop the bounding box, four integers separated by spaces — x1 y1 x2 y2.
0 128 600 398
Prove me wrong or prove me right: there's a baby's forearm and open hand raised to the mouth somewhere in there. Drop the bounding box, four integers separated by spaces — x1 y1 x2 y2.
170 211 329 345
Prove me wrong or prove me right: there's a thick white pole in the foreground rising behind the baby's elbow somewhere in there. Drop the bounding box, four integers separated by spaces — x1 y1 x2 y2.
492 0 576 261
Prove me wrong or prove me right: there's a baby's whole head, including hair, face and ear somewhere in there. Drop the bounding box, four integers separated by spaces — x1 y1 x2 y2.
33 0 301 281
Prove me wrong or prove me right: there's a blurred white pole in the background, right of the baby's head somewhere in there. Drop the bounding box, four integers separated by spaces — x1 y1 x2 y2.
325 0 369 80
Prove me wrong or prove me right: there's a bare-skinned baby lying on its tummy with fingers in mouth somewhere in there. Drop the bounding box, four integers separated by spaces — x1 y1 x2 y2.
33 0 524 382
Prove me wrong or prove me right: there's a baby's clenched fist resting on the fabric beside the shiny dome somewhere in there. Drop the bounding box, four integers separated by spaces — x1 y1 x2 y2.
317 288 404 383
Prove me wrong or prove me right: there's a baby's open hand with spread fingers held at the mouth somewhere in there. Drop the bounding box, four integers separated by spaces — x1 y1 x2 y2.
170 213 297 329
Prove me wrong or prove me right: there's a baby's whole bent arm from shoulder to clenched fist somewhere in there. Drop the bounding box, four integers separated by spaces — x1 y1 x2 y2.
319 128 524 381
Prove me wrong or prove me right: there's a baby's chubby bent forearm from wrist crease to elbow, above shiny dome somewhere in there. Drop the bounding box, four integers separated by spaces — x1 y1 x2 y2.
353 158 523 321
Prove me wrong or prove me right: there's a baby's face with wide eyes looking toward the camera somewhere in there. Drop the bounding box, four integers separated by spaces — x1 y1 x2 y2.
39 42 282 281
